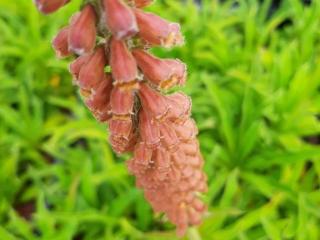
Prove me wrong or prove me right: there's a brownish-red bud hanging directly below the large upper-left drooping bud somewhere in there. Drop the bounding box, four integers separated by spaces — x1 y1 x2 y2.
76 47 106 91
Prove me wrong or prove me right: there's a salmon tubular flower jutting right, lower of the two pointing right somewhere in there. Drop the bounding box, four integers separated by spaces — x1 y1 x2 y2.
132 49 187 89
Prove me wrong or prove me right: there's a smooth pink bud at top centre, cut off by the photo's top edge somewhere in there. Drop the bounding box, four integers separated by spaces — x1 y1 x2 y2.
102 0 138 39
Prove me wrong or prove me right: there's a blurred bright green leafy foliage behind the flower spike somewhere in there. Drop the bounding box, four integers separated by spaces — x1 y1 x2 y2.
0 0 320 240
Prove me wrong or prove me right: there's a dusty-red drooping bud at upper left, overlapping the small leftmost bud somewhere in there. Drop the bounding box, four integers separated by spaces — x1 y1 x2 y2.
69 4 97 55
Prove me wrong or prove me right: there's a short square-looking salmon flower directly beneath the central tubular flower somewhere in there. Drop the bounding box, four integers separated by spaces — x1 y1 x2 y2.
110 86 134 116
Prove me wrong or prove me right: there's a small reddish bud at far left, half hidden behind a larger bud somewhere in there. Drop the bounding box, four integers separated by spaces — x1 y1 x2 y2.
52 27 71 58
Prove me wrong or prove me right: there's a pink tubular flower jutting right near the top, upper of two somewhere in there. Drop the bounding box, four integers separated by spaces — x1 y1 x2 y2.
135 9 184 48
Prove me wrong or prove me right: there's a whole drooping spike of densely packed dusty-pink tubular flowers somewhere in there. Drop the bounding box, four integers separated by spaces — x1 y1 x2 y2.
35 0 207 235
